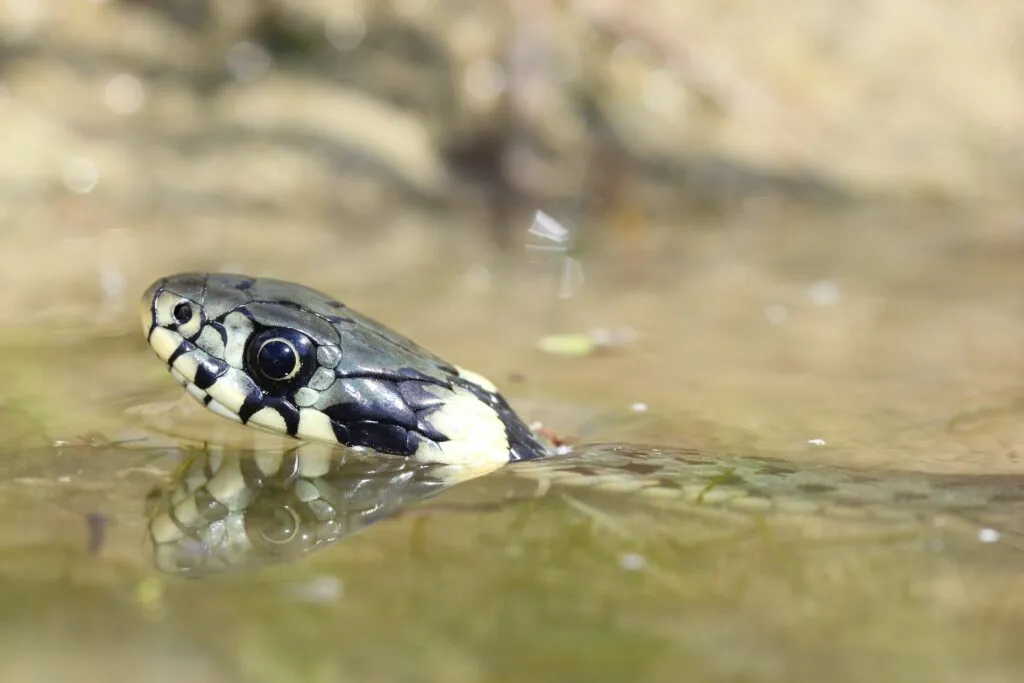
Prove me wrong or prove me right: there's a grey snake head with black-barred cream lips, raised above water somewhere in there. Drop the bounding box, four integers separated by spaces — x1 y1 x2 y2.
141 272 549 468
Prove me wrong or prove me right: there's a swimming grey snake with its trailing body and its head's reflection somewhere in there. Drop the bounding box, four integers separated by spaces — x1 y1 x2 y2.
140 272 1024 575
